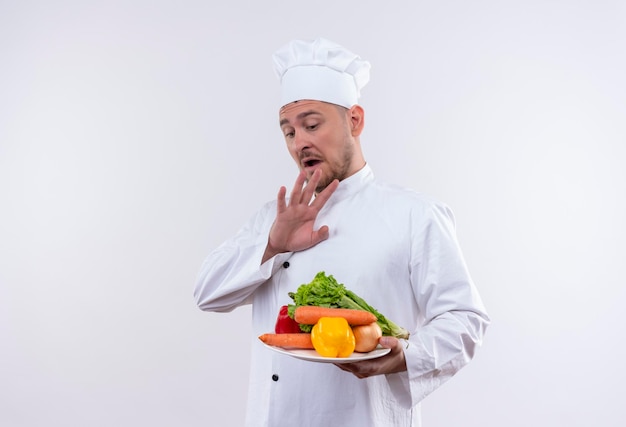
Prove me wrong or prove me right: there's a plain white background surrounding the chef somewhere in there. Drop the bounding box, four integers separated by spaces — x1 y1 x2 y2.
0 0 626 427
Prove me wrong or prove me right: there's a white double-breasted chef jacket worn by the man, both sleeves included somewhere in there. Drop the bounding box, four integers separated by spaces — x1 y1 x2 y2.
194 165 489 427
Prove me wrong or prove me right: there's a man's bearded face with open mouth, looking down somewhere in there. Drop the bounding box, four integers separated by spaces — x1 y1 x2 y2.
279 100 363 192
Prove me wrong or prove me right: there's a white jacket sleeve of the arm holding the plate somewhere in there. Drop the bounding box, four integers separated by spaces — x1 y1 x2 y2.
388 205 490 407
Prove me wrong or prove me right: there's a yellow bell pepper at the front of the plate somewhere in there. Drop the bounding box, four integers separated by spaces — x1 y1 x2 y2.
311 317 356 357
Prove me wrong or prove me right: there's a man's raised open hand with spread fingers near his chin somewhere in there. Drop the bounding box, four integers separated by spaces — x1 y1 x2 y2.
262 169 339 262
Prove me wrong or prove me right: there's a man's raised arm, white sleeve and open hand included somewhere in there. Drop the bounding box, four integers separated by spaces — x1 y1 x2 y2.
194 169 338 312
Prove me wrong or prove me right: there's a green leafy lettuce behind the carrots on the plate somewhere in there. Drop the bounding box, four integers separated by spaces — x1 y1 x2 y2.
288 271 409 339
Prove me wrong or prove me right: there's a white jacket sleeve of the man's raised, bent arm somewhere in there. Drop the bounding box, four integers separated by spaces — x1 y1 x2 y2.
194 203 290 312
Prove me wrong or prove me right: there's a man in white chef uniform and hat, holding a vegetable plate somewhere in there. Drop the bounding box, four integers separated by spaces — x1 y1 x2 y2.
195 39 489 427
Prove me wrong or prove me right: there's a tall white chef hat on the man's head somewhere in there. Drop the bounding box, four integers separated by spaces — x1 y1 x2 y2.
272 38 370 108
